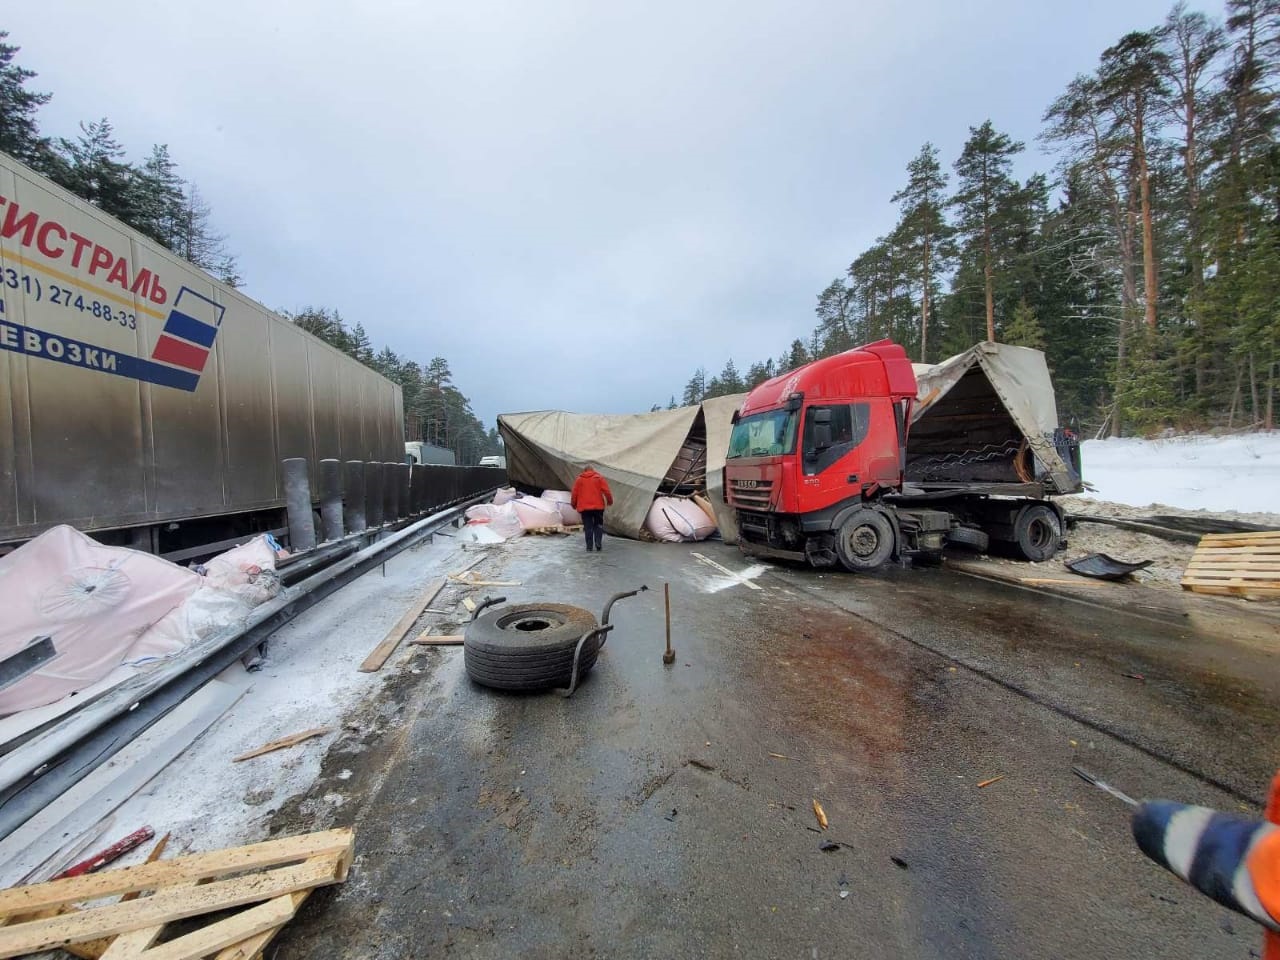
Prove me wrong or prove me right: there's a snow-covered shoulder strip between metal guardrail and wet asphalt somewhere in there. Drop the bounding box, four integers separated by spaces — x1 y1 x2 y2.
97 540 472 865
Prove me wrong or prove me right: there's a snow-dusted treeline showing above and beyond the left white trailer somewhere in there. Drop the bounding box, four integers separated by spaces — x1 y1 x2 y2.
0 31 500 463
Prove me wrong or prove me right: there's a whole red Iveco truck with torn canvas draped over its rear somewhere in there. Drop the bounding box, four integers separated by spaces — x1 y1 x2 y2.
724 340 1082 571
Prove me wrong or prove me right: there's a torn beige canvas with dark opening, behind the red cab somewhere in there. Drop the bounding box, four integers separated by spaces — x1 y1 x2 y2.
908 343 1079 493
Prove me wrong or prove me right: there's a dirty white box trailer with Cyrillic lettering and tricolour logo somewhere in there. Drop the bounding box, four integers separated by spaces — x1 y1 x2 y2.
0 154 404 550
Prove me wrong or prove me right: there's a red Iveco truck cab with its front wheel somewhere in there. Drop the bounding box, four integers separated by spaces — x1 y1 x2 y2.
724 340 946 570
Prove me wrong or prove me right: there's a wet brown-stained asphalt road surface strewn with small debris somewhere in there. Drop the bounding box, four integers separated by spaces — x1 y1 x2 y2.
274 538 1280 960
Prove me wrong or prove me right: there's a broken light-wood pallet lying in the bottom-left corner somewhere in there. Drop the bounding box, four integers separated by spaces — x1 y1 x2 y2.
0 829 355 960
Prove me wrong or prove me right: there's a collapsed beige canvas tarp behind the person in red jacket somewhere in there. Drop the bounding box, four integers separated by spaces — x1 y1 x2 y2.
498 396 742 539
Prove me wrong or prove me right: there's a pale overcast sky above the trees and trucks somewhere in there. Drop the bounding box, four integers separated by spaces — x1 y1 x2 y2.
0 0 1221 425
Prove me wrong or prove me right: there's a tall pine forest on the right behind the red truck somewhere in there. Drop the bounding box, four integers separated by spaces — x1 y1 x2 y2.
671 0 1280 435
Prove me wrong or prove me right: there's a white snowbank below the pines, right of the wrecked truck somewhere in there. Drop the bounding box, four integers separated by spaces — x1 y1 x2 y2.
1080 430 1280 513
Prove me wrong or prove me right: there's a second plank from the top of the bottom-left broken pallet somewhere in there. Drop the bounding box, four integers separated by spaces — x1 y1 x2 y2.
0 855 346 957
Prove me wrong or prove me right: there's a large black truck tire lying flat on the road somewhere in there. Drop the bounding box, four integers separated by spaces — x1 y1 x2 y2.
462 603 603 690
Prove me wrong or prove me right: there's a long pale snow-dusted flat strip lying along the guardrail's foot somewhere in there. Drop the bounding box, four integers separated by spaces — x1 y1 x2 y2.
0 673 248 896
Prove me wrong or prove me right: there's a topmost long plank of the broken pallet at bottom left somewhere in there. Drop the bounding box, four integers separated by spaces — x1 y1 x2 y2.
0 828 356 916
